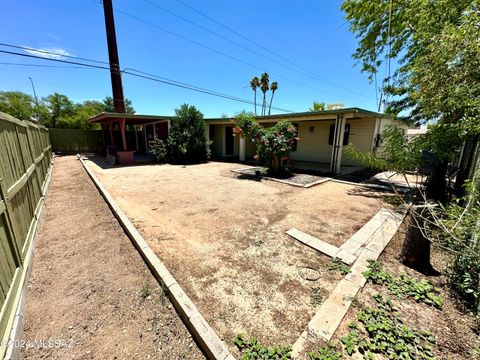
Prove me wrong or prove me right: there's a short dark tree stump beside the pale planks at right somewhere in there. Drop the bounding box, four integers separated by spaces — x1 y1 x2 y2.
400 206 437 274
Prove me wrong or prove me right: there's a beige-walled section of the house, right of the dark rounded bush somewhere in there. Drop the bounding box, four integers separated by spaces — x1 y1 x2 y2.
205 108 407 174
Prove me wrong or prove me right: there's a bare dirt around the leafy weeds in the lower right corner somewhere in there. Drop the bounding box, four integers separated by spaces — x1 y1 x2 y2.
332 224 480 360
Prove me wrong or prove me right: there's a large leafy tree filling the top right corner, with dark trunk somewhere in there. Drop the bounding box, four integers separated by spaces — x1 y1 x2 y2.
342 0 480 201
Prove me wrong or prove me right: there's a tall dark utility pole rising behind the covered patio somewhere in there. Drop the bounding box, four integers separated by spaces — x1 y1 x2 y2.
103 0 127 114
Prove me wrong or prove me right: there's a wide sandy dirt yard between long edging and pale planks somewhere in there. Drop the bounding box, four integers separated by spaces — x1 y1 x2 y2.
83 158 390 349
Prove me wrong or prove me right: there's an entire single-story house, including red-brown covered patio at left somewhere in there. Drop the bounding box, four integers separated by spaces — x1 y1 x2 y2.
89 108 408 174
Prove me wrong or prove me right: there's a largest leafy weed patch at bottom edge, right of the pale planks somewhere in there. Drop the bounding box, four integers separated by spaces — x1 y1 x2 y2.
340 294 435 360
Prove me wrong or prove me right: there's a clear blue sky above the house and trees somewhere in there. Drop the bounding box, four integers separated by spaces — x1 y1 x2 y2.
0 0 376 117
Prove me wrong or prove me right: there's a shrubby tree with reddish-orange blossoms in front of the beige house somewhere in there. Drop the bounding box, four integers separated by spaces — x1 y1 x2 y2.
233 112 299 175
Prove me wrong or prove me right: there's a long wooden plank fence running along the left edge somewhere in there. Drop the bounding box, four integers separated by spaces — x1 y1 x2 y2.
0 112 51 359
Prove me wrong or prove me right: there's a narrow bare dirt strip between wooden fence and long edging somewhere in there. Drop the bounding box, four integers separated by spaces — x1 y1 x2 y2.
21 156 204 359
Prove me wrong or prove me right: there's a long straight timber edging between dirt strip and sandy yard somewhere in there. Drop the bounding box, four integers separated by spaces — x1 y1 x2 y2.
77 154 235 360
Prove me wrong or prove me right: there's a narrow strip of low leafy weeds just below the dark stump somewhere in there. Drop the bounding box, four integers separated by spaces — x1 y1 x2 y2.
363 260 443 308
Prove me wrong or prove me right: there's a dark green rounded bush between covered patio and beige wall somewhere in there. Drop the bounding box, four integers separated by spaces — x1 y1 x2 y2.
167 104 210 164
